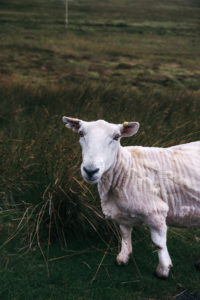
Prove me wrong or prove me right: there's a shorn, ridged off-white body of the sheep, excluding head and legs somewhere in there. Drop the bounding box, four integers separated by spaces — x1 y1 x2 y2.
98 142 200 227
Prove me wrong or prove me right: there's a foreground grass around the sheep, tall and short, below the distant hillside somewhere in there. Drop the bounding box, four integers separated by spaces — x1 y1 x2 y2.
0 84 200 300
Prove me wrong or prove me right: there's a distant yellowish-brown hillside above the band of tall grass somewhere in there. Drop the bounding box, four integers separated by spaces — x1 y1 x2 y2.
0 0 200 90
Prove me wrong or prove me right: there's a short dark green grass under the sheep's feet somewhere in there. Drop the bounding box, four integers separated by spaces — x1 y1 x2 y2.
0 228 200 300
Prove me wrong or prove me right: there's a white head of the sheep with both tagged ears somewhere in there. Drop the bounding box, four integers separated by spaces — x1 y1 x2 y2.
63 117 139 183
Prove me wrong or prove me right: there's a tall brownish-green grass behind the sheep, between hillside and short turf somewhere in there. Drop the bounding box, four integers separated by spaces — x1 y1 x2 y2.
0 83 200 248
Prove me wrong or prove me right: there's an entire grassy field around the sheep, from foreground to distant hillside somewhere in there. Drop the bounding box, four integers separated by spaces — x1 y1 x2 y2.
0 0 200 300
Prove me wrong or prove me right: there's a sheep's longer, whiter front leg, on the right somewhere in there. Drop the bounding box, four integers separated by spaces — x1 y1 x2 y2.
149 217 172 278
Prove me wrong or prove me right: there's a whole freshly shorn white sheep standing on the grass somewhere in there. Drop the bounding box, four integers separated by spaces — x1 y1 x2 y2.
63 117 200 278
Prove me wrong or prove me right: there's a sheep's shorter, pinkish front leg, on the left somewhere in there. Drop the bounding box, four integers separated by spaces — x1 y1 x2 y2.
116 225 132 266
